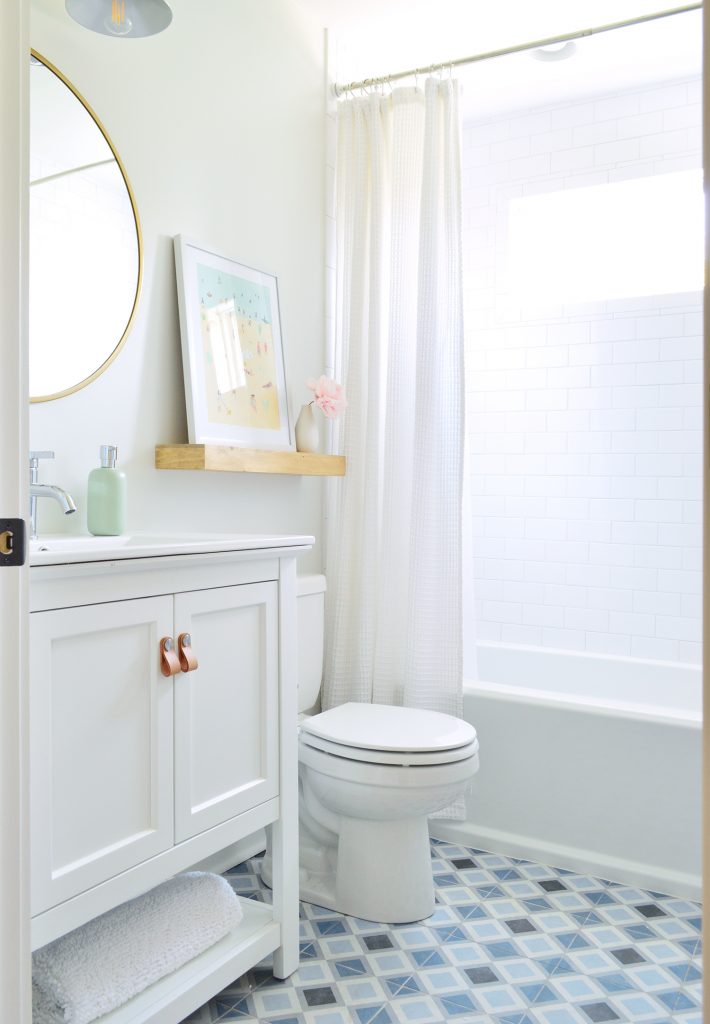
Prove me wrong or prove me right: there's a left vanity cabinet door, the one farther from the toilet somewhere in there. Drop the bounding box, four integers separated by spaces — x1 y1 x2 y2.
30 596 173 913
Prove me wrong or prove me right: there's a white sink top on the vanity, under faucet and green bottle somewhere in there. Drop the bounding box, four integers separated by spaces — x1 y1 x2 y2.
30 534 314 565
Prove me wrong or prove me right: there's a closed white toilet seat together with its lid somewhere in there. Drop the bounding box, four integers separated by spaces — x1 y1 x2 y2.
300 703 478 766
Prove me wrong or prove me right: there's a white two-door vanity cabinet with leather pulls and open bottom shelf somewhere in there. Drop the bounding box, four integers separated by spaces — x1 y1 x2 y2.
30 538 311 1024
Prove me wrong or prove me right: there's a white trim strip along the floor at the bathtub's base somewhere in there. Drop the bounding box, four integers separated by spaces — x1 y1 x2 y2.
429 818 702 900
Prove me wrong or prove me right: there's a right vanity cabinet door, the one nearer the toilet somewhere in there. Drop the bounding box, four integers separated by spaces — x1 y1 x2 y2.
175 583 279 843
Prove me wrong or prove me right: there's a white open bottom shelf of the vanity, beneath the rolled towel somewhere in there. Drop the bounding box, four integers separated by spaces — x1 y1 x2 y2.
95 897 281 1024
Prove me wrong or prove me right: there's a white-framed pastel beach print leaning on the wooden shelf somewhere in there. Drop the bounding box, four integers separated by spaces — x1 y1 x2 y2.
175 234 294 451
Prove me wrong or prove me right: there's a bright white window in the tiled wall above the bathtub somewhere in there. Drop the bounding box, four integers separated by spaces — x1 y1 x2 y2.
509 171 704 304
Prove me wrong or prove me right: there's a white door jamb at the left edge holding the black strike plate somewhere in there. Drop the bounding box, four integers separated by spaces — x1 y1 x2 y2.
0 0 32 1024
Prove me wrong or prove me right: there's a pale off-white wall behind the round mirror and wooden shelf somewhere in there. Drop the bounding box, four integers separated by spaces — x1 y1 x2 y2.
31 0 325 569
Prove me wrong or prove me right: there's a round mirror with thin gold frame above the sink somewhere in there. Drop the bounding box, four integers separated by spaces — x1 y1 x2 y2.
30 51 142 401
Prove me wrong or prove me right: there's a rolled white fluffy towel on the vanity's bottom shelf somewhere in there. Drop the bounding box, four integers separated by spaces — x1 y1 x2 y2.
32 871 242 1024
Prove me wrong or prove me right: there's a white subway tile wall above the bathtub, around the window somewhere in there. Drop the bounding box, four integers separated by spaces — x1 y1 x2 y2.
463 78 702 675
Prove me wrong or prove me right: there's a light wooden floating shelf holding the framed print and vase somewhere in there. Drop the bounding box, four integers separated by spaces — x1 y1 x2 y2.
156 444 345 476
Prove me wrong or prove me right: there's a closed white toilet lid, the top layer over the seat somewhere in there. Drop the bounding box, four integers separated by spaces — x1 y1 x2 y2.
300 703 477 763
